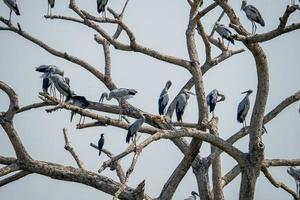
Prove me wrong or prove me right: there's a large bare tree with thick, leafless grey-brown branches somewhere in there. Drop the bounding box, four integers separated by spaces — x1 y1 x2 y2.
0 0 300 200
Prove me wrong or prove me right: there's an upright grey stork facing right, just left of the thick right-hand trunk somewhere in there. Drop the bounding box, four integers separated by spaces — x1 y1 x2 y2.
237 90 253 128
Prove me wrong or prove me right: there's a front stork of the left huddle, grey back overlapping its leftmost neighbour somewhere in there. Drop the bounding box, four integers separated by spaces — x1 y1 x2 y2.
47 68 72 102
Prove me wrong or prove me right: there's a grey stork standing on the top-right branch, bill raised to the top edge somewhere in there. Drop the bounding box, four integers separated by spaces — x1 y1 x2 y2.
241 0 265 34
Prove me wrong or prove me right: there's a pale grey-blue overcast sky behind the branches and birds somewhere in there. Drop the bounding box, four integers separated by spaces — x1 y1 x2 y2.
0 0 300 200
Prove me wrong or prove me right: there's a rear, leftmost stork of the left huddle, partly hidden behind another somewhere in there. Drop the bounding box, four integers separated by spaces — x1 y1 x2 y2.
35 65 64 96
